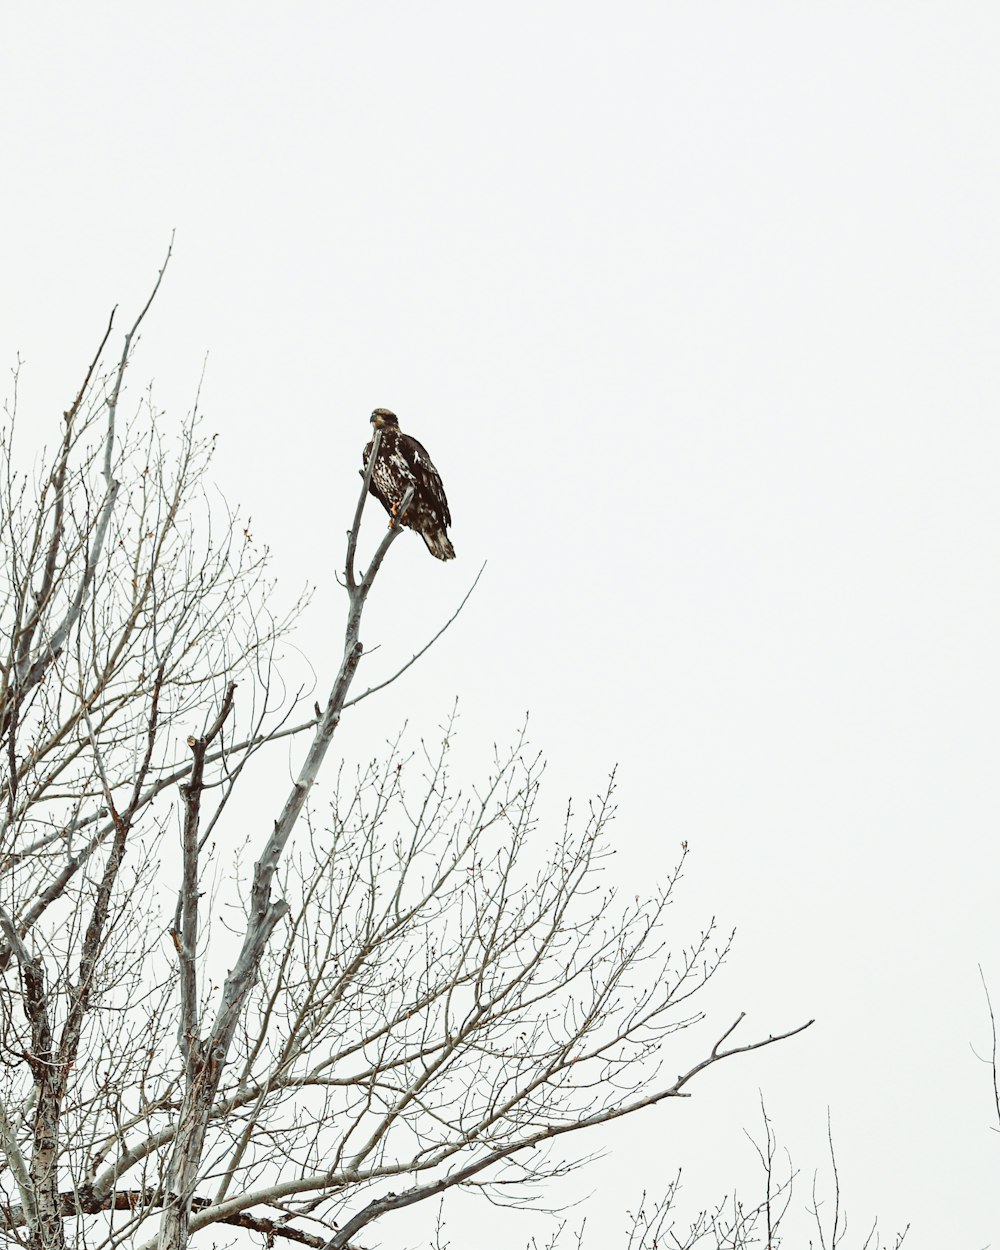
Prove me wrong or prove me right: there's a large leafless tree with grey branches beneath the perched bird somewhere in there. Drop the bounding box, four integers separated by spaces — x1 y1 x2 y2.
0 256 805 1250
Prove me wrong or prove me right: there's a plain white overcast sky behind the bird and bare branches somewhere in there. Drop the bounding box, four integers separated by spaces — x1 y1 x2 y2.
0 0 1000 1250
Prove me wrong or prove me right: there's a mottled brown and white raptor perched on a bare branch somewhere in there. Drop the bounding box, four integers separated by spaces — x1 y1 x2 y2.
361 408 455 560
